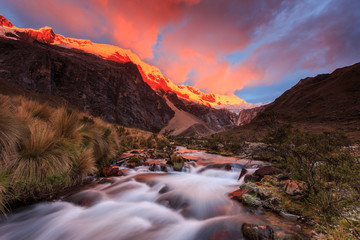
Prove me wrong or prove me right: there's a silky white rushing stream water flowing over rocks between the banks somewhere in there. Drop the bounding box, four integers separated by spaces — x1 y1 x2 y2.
0 149 300 240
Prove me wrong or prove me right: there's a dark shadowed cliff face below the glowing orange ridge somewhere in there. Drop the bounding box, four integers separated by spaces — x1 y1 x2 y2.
0 38 174 130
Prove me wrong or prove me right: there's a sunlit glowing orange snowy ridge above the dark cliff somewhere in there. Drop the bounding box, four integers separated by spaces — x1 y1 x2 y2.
0 15 256 109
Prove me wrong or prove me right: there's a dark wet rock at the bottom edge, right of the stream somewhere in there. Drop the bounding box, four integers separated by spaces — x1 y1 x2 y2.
241 223 274 240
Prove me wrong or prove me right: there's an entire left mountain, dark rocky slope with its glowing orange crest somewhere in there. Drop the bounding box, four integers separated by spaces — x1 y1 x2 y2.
0 16 246 135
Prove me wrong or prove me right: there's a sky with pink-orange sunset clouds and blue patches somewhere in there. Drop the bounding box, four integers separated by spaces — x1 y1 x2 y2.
0 0 360 103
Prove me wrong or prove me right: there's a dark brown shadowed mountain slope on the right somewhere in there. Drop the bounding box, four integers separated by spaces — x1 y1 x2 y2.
224 63 360 140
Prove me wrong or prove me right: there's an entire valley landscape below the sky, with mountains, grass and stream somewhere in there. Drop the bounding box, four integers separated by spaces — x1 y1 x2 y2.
0 10 360 240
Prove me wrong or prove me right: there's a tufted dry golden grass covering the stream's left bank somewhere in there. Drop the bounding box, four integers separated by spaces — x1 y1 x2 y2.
0 94 167 213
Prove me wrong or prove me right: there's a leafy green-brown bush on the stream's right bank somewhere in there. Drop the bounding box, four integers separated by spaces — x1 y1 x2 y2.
265 125 360 221
